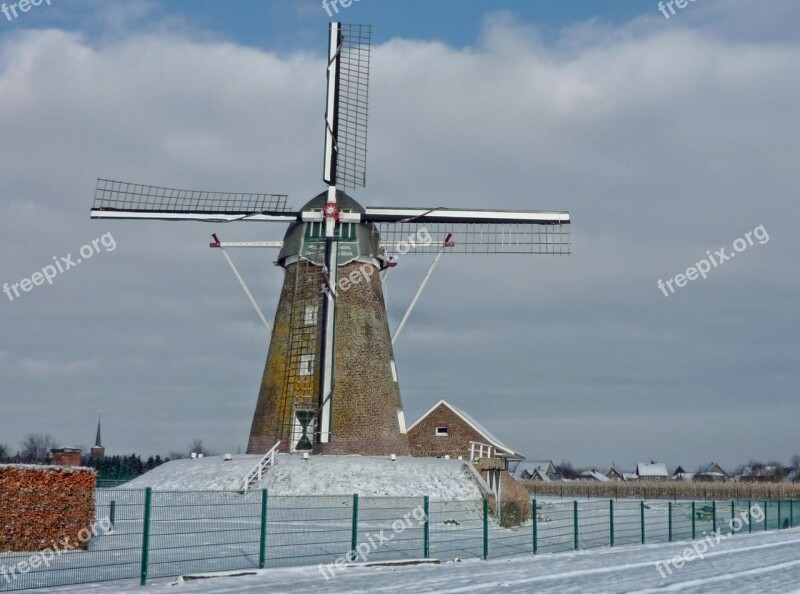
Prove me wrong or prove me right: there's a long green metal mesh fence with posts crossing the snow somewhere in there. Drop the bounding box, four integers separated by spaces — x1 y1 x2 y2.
0 489 800 591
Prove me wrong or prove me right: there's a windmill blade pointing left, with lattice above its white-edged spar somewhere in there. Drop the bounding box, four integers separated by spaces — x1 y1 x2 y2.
91 179 300 223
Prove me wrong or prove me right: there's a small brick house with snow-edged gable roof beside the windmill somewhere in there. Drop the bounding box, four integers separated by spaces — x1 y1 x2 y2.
408 400 525 469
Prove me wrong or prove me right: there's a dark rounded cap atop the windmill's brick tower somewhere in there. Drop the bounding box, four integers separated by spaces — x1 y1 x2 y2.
277 190 389 270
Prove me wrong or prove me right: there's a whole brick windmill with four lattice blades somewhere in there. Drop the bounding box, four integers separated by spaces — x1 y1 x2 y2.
91 23 570 455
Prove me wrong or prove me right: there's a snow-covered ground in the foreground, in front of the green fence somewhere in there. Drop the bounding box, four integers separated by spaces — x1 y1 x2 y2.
42 529 800 594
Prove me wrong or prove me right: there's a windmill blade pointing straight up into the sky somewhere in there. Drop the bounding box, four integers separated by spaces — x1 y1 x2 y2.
325 23 372 189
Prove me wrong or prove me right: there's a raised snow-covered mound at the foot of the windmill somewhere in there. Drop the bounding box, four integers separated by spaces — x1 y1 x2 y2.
123 454 481 501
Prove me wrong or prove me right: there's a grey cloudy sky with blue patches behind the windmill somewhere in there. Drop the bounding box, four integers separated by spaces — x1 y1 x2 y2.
0 0 800 468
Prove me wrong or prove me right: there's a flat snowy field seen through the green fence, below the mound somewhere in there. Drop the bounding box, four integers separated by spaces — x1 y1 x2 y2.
0 490 800 591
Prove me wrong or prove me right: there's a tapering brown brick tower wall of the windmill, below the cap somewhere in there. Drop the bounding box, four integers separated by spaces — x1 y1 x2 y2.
247 262 409 456
